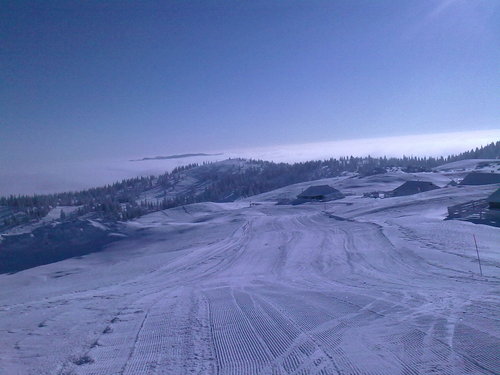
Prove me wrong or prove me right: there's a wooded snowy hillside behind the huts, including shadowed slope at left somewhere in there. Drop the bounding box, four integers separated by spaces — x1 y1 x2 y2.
0 152 500 272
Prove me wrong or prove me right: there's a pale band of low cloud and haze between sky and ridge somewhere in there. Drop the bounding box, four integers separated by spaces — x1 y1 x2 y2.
0 130 500 196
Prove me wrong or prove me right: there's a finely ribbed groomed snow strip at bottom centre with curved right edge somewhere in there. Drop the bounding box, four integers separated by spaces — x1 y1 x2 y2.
206 288 338 375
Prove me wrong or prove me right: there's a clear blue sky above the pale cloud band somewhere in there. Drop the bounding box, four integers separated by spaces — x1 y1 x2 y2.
0 0 500 166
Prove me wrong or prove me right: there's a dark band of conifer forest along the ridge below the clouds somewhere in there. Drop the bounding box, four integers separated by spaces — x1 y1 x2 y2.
0 141 500 227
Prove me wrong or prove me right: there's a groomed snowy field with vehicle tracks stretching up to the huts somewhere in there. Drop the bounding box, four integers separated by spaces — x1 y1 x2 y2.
0 171 500 375
